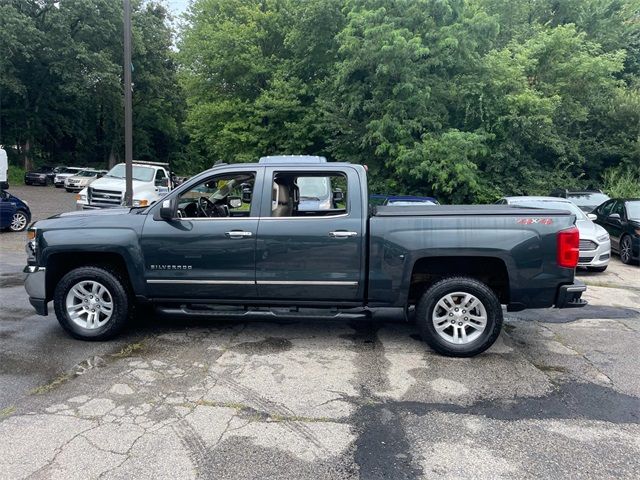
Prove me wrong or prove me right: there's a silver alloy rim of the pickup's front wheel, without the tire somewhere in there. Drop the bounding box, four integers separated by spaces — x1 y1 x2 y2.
65 280 113 329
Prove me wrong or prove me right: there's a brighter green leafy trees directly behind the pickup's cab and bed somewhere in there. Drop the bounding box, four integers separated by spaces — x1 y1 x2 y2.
179 0 640 202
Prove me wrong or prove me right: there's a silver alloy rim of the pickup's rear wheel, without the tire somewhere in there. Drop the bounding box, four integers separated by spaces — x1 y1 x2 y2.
431 292 487 345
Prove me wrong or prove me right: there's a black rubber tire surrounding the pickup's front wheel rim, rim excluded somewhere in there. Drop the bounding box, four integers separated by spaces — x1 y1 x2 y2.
53 267 132 340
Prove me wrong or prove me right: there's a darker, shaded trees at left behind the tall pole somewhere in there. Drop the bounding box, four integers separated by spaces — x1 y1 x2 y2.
0 0 184 168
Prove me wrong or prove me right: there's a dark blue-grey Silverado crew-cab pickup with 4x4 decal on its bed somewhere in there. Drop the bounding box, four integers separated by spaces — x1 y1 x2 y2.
25 157 586 356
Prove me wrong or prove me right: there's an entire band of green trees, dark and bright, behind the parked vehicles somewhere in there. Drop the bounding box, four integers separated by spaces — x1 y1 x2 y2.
0 0 640 202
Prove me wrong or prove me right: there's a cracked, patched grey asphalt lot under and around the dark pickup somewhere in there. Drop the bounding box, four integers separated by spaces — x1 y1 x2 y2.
0 187 640 479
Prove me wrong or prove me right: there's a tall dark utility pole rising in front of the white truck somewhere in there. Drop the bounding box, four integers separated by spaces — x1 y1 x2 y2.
124 0 133 207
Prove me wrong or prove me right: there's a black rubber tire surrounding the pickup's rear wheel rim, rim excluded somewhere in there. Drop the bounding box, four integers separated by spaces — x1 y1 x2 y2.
416 277 502 357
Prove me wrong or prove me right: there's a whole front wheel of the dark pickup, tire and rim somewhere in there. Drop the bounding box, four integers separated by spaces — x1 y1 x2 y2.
53 267 131 340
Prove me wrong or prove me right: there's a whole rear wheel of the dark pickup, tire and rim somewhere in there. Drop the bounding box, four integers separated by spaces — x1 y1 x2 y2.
416 277 502 357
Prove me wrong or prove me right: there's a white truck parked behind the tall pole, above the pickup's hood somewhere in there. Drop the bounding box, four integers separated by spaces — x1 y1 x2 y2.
76 161 172 210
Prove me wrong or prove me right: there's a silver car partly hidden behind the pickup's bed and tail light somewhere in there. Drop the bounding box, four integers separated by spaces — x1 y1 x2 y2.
497 197 611 272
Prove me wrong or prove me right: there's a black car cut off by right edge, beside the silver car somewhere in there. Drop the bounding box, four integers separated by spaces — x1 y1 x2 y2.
593 198 640 264
